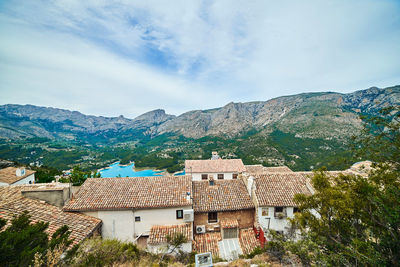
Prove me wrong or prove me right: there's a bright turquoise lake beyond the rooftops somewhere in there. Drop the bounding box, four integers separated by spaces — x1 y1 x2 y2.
100 162 162 178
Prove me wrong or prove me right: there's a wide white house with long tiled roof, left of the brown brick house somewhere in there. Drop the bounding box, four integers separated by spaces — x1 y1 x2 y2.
64 176 193 252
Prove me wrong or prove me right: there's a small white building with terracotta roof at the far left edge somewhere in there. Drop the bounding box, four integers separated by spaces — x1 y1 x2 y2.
0 167 35 186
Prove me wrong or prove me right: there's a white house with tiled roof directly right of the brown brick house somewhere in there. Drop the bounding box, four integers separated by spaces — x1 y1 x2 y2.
247 172 312 232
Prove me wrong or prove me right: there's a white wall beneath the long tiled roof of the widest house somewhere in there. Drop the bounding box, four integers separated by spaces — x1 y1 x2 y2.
83 206 192 241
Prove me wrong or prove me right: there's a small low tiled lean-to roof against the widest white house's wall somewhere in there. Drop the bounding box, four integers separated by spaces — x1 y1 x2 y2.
147 223 193 244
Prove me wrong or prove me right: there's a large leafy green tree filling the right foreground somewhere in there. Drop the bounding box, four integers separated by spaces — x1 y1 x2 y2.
276 108 400 266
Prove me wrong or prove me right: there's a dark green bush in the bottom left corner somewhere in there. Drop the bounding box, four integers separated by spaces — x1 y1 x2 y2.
0 212 71 266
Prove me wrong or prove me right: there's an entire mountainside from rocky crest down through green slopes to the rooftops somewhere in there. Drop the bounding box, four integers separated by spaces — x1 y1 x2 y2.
0 86 400 172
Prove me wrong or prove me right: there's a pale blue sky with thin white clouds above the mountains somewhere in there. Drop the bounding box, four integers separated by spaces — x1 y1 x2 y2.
0 0 400 118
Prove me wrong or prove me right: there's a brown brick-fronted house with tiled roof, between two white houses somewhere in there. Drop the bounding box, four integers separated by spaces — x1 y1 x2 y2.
193 179 259 259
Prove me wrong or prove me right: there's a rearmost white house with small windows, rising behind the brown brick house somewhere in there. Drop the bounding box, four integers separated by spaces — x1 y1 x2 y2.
185 155 246 181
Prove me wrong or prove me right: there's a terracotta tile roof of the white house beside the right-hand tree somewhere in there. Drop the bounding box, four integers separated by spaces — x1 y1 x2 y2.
254 172 311 206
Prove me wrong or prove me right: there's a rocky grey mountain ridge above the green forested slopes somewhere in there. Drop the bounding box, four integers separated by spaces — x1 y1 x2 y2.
0 86 400 139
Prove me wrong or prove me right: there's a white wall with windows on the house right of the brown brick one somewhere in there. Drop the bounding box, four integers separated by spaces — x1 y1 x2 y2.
257 207 293 232
